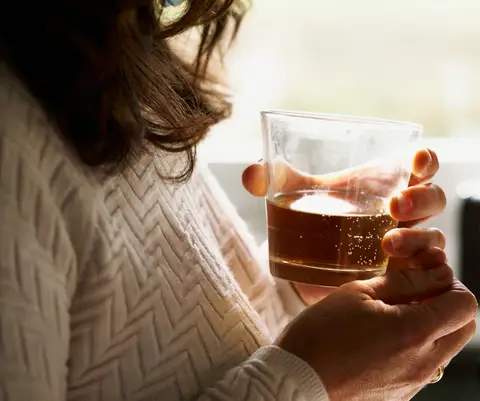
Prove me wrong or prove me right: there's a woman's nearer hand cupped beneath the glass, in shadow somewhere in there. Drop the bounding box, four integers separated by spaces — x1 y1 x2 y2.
276 248 477 401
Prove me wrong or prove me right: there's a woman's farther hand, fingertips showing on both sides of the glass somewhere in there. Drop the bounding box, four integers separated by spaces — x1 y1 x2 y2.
242 149 446 305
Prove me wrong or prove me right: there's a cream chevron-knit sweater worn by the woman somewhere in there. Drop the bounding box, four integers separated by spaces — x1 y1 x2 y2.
0 66 328 401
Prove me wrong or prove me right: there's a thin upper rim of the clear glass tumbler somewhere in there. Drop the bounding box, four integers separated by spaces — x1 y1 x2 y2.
260 109 423 131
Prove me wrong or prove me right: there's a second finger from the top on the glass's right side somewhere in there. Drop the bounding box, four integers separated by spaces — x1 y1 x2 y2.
390 184 447 221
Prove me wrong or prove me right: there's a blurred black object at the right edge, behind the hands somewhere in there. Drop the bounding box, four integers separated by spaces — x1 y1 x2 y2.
460 195 480 302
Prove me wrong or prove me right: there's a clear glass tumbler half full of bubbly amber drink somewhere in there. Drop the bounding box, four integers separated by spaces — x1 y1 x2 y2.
262 111 422 287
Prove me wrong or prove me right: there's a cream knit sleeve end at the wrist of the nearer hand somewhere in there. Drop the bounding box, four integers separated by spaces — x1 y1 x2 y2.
198 346 328 401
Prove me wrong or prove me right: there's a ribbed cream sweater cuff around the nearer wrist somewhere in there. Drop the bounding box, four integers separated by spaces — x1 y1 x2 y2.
252 345 329 401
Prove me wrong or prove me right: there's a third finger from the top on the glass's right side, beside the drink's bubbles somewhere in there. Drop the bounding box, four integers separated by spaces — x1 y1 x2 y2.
382 228 445 256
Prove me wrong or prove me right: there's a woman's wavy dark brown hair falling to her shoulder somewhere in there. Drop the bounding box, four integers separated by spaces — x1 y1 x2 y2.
0 0 247 181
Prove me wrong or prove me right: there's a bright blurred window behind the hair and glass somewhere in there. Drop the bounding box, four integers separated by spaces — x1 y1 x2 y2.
204 0 480 154
